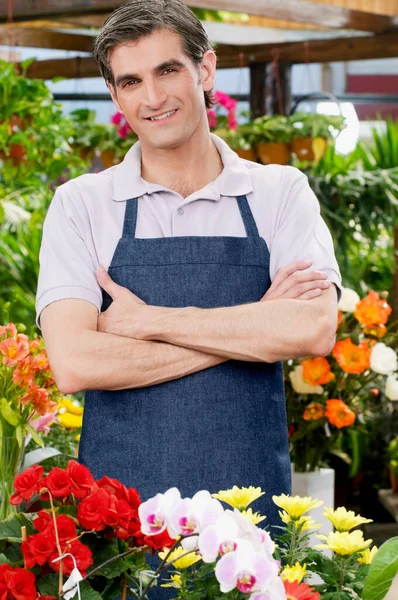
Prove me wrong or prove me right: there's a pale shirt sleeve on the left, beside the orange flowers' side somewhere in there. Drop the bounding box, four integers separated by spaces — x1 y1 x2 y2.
36 184 102 329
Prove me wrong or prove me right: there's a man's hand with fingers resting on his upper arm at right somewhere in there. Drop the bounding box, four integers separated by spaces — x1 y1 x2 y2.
261 260 331 301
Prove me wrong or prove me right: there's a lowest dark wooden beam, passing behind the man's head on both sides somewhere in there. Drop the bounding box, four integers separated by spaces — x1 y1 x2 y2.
21 33 398 79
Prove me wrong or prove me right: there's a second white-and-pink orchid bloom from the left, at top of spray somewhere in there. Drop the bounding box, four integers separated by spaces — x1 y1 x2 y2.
168 490 224 550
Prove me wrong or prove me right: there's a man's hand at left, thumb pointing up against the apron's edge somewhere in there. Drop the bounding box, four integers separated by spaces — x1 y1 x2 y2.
97 267 148 339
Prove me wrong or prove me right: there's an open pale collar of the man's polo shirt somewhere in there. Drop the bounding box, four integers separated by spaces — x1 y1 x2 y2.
113 134 253 202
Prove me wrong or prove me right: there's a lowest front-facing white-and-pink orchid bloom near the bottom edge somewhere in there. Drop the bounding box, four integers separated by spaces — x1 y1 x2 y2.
215 540 278 594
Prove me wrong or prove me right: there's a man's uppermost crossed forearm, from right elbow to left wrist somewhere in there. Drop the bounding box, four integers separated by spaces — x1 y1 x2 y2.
141 289 337 362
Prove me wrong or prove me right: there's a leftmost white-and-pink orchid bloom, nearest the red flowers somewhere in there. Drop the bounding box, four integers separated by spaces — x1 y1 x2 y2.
138 488 181 538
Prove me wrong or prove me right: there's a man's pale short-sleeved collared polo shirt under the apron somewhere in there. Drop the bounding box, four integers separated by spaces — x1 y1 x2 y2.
36 135 341 327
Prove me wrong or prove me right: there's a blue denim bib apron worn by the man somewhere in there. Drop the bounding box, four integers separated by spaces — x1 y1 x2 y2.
79 196 290 525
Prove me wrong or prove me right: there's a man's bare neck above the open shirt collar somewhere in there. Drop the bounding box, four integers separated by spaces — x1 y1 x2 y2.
141 130 223 197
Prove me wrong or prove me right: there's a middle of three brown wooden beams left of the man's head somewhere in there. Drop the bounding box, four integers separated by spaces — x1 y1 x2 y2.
0 27 94 52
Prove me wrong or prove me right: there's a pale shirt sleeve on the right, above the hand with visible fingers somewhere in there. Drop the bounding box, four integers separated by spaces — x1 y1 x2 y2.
270 167 341 299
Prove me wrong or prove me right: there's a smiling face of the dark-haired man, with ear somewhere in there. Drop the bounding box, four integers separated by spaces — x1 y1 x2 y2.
107 29 215 149
